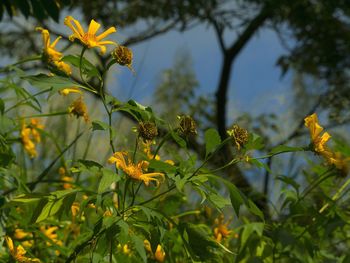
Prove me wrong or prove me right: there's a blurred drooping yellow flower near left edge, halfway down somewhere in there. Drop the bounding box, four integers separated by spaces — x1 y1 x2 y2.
21 119 44 158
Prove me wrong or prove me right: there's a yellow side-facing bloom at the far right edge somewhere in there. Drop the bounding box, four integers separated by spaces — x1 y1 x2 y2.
304 113 350 175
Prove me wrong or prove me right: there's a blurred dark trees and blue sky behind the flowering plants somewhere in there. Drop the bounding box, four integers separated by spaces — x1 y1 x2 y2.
0 0 350 218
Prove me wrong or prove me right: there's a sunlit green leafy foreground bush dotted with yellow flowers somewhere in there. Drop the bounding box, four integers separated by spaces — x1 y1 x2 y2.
0 13 350 262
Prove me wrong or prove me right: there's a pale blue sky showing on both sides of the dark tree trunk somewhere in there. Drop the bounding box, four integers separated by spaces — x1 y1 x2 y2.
114 22 291 118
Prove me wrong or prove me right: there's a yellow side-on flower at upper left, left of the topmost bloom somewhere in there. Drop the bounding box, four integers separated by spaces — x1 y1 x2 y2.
36 27 72 75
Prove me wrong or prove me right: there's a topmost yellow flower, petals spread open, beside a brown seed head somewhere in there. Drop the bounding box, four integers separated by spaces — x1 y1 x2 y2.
64 16 117 54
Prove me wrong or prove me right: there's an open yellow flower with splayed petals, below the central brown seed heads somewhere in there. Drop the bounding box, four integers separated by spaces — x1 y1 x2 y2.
108 152 164 186
